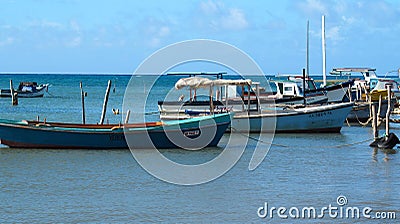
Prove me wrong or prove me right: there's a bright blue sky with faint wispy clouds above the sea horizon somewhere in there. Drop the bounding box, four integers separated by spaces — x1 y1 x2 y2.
0 0 400 74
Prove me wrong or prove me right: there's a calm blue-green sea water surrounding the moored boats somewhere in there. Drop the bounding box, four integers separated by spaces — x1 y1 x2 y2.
0 75 400 223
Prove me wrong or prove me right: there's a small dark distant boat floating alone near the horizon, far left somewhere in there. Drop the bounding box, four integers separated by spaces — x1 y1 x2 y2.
0 82 49 98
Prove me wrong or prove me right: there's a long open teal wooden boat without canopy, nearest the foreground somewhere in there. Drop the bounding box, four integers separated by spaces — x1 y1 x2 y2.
0 113 231 149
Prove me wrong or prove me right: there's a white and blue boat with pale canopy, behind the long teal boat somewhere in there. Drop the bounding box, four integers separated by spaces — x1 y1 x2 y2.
159 78 354 133
